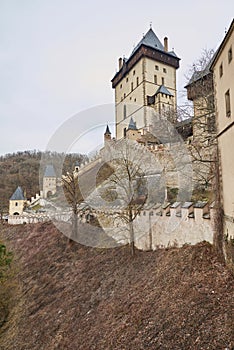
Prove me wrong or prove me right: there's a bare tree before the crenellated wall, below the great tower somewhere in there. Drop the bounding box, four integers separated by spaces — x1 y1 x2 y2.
100 139 161 256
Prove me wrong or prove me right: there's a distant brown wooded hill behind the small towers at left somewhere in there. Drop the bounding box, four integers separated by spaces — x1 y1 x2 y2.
0 151 87 213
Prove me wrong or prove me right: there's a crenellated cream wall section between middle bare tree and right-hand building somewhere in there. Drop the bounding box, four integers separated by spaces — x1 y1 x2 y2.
135 203 215 250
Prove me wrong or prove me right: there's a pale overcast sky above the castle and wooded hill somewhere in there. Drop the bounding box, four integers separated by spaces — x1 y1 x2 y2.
0 0 234 154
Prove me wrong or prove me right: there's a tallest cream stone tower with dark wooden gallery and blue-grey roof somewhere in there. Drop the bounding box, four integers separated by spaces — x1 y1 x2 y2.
111 28 180 139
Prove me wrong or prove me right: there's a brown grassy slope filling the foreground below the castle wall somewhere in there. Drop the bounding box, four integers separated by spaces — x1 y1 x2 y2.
0 223 234 350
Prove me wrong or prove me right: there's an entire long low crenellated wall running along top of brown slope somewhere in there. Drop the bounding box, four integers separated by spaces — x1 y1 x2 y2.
8 202 215 250
